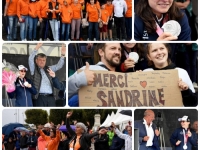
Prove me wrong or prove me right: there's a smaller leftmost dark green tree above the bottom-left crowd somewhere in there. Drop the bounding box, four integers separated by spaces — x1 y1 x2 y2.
25 109 48 126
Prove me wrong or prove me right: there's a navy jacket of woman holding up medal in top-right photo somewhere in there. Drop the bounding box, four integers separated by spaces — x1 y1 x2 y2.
134 11 191 41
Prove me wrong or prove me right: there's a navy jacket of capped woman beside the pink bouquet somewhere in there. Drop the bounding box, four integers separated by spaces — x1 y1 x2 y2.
8 78 37 107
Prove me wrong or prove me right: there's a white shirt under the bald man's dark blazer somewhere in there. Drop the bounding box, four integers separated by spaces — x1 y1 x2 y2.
144 119 154 146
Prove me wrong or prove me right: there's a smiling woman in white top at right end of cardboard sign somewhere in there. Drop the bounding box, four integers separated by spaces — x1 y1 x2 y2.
144 43 197 106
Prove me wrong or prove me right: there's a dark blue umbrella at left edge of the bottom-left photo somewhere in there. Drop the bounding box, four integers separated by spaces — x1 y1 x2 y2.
2 122 24 135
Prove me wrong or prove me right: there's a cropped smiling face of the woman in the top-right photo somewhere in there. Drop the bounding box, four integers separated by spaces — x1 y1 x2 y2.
148 0 173 17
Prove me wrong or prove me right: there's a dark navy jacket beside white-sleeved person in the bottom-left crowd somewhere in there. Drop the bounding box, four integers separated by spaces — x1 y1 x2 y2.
110 134 124 150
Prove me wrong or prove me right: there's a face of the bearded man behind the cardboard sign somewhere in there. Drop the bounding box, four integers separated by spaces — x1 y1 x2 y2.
99 43 121 68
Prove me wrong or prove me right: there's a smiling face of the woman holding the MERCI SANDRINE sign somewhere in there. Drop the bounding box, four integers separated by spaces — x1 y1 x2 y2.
147 43 168 68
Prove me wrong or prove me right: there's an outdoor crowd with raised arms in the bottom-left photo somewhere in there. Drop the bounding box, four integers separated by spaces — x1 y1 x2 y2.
2 112 132 150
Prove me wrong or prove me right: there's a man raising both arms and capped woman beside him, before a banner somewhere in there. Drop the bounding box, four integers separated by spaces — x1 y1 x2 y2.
3 43 66 107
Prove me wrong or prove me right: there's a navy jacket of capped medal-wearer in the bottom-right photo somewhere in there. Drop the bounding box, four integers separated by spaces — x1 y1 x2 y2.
170 127 197 150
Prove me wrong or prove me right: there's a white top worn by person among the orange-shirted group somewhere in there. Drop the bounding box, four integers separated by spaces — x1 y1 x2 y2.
112 0 127 17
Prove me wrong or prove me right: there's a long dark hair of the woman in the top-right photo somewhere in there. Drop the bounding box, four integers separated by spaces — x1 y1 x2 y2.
135 0 183 33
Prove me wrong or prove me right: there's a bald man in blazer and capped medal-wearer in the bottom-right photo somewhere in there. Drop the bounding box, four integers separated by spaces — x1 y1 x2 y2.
134 109 198 150
